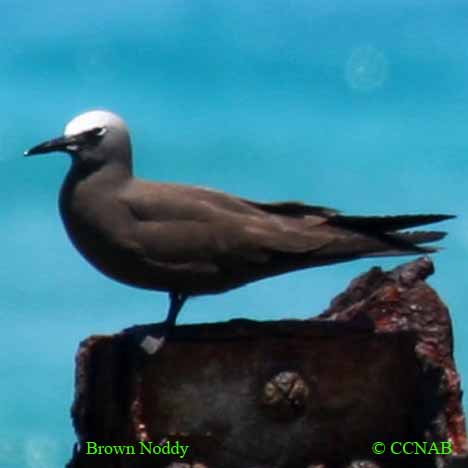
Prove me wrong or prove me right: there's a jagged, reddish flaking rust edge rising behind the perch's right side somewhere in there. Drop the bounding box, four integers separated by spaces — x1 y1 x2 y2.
319 257 468 454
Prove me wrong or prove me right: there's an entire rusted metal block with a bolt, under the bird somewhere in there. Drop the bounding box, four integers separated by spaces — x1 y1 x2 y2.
69 259 467 468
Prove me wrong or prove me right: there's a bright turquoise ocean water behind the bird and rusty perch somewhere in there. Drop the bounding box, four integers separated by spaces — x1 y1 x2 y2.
0 0 468 468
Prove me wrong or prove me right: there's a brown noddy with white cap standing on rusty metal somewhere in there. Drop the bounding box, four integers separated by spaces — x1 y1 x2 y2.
24 110 454 351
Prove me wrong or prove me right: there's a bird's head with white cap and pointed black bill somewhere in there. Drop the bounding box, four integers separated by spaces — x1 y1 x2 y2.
24 110 131 172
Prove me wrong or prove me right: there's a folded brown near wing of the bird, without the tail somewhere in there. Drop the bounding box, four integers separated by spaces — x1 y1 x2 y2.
121 181 336 267
